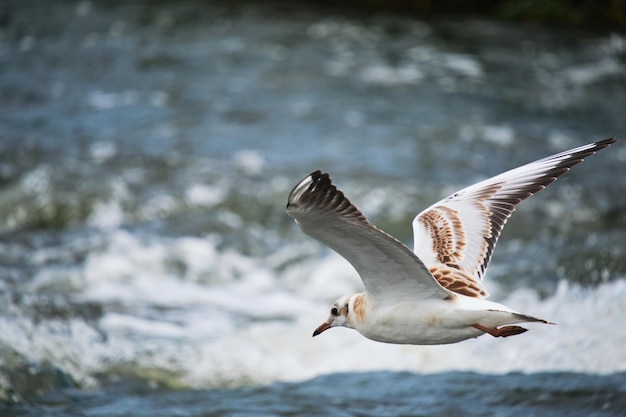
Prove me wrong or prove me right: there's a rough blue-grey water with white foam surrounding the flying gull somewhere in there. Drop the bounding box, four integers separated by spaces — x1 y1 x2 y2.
0 1 626 416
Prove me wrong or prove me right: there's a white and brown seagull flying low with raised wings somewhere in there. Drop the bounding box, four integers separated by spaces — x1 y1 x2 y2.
287 138 616 345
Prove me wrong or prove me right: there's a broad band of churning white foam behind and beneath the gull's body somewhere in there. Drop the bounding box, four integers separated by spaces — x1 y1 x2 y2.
6 230 626 387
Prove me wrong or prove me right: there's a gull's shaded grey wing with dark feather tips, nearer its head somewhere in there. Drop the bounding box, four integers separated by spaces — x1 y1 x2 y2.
287 171 451 304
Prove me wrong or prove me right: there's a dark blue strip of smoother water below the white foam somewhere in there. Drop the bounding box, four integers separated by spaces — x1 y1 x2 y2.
0 372 626 417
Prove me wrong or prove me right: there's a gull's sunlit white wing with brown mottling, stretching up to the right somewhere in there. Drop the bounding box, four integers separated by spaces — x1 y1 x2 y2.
413 138 615 297
